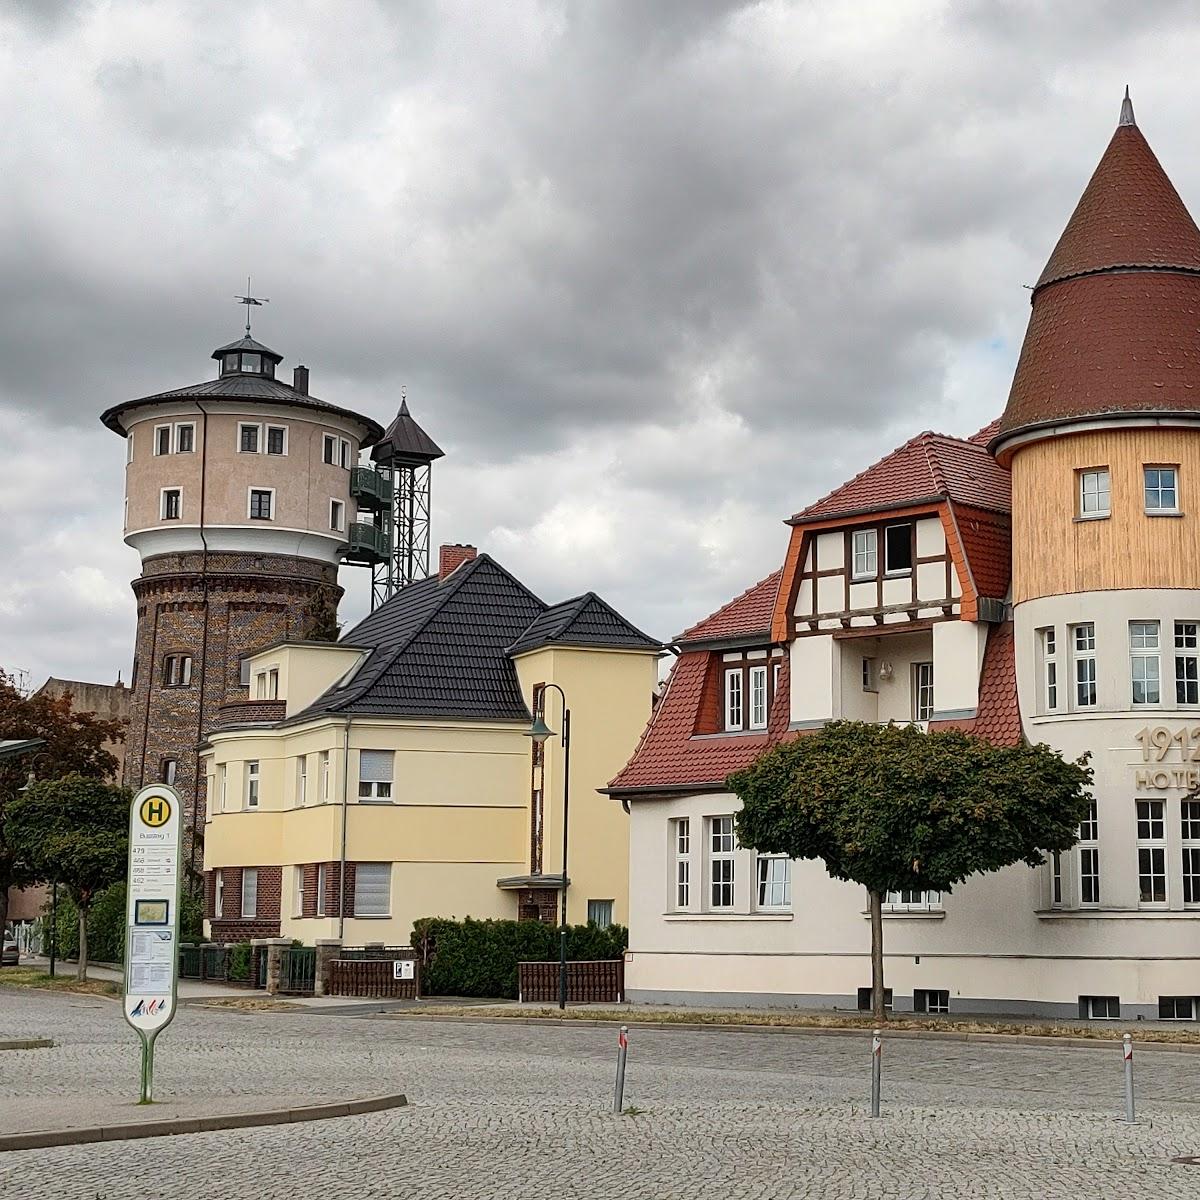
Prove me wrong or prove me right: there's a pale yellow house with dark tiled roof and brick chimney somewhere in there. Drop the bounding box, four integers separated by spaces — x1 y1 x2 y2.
202 546 661 944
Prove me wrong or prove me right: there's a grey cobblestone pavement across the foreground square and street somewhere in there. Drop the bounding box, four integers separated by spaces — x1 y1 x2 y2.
0 988 1200 1200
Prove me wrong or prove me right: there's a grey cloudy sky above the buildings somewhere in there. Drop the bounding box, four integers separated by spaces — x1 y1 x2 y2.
0 0 1200 684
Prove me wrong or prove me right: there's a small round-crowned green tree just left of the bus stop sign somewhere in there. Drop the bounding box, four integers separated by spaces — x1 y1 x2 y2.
8 774 131 979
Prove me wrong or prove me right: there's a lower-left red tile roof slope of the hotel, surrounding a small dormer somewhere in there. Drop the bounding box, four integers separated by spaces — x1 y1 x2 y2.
607 650 791 793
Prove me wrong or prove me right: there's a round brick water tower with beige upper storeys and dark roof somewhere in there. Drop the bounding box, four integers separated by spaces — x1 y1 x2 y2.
101 335 383 878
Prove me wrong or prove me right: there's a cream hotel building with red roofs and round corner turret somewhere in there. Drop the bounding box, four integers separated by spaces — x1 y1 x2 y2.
610 93 1200 1019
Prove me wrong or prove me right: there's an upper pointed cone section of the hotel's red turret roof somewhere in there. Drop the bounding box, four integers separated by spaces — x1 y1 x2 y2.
1037 125 1200 290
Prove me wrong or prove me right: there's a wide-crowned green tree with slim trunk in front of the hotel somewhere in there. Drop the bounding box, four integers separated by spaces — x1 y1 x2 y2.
728 721 1092 1021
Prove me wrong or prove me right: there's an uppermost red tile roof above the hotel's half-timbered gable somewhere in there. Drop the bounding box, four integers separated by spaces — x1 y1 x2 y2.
792 431 1012 522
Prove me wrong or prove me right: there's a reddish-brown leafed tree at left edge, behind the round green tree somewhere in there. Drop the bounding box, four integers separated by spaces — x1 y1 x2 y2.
0 668 125 930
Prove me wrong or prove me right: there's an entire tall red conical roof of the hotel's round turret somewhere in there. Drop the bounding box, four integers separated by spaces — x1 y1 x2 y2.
991 91 1200 457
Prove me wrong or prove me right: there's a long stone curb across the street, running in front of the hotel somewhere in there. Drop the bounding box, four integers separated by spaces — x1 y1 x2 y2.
382 1013 1200 1054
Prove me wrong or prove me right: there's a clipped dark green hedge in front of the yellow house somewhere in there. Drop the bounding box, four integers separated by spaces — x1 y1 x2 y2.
413 917 629 1000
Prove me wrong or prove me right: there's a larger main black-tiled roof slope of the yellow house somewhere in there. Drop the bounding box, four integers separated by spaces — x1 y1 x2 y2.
297 554 546 721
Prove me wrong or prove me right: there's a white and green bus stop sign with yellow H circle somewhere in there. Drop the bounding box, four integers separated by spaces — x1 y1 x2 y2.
124 784 184 1104
